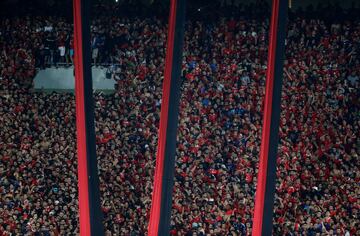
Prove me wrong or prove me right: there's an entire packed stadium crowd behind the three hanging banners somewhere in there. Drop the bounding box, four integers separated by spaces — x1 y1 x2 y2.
0 0 360 235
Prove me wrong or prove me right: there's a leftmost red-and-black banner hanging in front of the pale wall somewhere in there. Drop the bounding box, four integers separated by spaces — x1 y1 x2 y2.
73 0 104 236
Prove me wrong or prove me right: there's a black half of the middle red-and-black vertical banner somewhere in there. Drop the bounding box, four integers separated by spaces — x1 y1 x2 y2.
158 0 185 235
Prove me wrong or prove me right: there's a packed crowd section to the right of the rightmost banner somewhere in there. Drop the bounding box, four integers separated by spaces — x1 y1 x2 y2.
274 19 360 235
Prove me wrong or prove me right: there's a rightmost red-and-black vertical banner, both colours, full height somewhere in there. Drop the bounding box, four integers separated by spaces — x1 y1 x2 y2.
252 0 288 236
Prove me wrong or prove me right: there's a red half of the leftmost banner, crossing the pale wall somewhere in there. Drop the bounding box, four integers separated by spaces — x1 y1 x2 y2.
73 0 90 236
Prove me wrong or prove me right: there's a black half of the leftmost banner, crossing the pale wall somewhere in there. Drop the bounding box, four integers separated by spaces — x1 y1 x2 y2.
80 0 104 236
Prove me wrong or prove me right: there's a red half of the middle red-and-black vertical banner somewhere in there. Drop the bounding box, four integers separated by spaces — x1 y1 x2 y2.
148 0 177 236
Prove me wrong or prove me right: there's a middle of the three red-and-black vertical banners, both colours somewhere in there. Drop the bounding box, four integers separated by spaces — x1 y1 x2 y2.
148 0 185 236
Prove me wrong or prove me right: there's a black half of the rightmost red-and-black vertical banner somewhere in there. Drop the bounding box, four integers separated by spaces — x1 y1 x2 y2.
262 0 288 235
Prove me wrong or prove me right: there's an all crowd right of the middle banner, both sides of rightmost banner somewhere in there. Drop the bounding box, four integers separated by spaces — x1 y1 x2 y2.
172 10 360 235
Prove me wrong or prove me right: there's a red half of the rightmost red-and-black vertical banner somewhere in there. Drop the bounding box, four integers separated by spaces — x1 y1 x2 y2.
252 0 279 236
